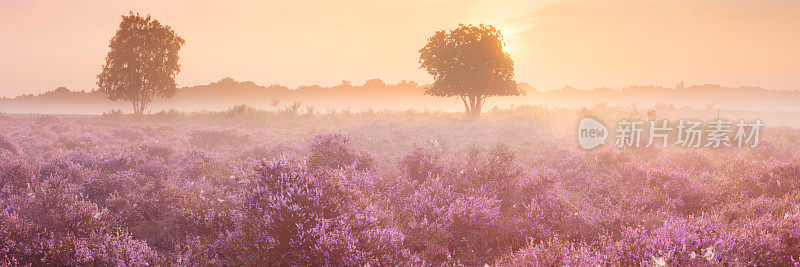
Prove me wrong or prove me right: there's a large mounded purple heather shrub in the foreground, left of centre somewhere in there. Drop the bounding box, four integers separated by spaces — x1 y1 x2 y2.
182 159 405 265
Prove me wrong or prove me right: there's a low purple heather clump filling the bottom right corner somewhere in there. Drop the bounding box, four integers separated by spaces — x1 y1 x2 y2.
602 212 800 266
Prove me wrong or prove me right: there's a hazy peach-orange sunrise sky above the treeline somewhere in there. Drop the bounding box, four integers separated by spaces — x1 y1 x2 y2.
0 0 800 97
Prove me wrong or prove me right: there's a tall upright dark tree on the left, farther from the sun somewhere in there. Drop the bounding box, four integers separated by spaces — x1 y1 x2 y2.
97 12 184 114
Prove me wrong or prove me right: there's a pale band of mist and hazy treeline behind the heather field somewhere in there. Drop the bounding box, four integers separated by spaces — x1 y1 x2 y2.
0 78 800 126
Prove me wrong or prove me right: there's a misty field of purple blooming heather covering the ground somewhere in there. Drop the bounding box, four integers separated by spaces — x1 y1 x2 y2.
0 106 800 266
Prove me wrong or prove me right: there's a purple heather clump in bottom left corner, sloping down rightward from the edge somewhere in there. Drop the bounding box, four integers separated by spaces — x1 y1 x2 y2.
0 168 156 265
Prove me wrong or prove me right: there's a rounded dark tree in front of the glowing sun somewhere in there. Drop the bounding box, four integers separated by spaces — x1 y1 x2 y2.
419 24 521 117
